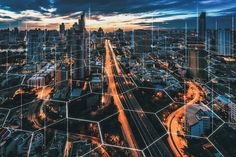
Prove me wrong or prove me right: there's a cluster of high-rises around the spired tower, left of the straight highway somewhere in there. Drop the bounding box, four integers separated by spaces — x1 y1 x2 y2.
22 13 104 87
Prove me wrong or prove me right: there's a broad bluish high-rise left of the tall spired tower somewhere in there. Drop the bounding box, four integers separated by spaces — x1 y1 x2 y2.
26 30 44 63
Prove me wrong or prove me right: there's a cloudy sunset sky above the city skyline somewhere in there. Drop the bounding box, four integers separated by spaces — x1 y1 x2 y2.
0 0 236 31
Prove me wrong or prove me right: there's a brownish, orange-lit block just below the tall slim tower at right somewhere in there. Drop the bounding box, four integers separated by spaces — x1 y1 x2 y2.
188 43 208 80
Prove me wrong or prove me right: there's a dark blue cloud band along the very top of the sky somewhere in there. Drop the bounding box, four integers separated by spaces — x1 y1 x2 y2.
0 0 236 15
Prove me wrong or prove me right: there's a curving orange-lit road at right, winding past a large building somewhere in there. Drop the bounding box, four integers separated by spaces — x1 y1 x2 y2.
165 81 204 157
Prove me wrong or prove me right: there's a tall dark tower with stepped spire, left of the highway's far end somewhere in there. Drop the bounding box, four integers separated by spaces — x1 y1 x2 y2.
71 13 88 80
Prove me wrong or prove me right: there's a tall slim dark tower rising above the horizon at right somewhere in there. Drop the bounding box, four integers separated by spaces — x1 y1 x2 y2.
198 12 206 42
